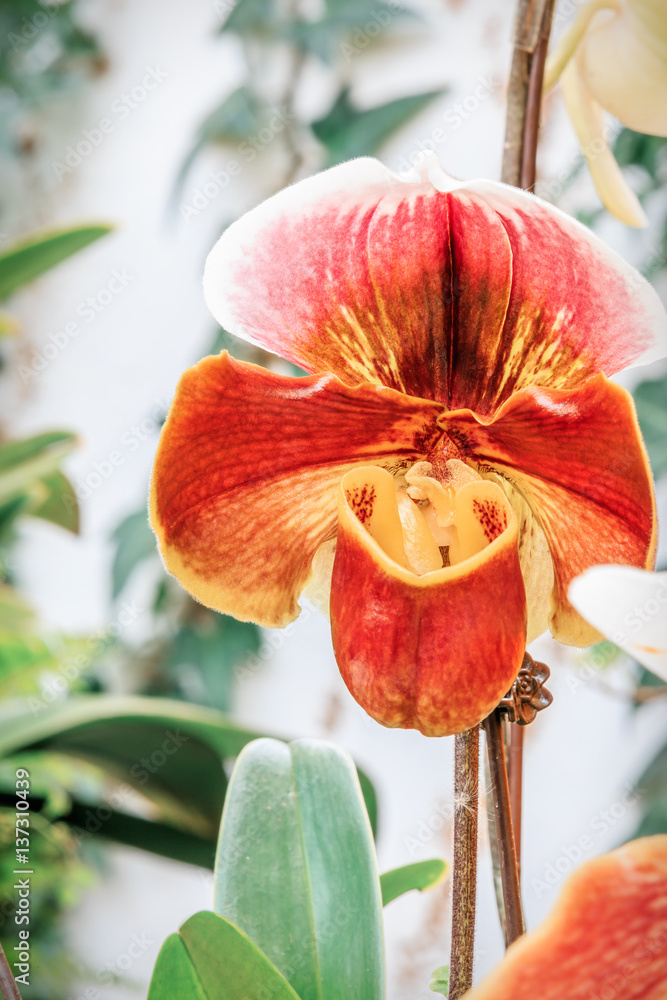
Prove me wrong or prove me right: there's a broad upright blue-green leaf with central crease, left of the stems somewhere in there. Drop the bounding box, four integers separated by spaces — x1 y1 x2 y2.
214 739 384 1000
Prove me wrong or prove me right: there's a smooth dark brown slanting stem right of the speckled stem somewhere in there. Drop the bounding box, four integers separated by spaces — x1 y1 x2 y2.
482 709 524 947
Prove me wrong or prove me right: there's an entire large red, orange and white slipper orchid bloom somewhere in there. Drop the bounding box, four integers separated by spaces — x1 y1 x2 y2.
151 159 667 735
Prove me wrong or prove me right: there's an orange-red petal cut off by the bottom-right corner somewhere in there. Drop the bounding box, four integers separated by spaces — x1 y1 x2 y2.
465 835 667 1000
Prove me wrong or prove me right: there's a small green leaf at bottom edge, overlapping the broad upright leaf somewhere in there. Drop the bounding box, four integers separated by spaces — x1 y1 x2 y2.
148 910 299 1000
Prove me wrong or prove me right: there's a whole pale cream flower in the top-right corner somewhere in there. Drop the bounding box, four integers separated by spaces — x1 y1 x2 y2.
544 0 667 226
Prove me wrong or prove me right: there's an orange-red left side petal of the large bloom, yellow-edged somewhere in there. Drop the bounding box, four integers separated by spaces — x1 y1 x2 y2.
151 353 441 626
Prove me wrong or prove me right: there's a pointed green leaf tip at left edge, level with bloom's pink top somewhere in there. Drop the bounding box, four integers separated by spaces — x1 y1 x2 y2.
0 225 112 301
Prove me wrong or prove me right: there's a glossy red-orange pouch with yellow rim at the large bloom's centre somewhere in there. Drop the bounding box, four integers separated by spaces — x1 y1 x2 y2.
331 467 526 736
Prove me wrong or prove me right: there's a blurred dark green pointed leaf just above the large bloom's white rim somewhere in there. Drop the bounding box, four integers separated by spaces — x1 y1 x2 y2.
311 88 445 166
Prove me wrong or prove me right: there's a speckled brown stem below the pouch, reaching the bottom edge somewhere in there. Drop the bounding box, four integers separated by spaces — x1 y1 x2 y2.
448 726 479 1000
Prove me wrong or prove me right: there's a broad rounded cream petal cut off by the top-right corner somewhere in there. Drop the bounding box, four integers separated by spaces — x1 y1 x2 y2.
577 0 667 136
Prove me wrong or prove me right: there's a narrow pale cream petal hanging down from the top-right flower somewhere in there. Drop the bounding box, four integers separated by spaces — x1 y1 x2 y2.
561 59 648 228
